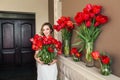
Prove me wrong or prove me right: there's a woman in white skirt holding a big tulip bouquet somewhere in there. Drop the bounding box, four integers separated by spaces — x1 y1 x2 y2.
34 23 58 80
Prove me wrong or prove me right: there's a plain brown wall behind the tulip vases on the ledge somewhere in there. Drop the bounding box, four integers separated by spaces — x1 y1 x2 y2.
62 0 120 77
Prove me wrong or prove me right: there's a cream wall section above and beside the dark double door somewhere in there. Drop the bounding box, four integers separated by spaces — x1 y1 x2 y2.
0 0 48 33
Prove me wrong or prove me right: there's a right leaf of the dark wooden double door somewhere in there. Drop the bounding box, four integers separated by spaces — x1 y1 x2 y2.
20 20 34 64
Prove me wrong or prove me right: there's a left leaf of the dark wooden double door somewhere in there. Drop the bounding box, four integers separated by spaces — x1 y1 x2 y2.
0 20 15 65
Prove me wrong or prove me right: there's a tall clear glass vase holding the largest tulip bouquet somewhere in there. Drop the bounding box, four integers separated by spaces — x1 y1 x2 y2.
85 41 94 67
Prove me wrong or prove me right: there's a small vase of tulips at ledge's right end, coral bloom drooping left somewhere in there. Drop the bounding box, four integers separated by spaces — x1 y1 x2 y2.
92 51 111 75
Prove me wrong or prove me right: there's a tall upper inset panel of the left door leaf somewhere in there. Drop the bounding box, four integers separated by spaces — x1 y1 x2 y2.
2 23 15 49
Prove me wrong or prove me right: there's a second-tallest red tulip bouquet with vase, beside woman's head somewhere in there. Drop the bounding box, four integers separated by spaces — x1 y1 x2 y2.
54 16 74 56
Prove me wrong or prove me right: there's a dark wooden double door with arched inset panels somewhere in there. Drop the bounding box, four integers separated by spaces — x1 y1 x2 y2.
0 19 35 66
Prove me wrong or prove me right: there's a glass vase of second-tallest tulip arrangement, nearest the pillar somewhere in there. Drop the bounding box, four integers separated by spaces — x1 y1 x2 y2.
63 39 70 57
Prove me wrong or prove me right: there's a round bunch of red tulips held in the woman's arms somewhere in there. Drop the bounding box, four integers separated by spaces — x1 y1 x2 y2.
30 34 62 64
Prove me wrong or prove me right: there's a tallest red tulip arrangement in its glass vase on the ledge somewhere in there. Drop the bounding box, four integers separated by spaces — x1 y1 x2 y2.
74 4 108 66
